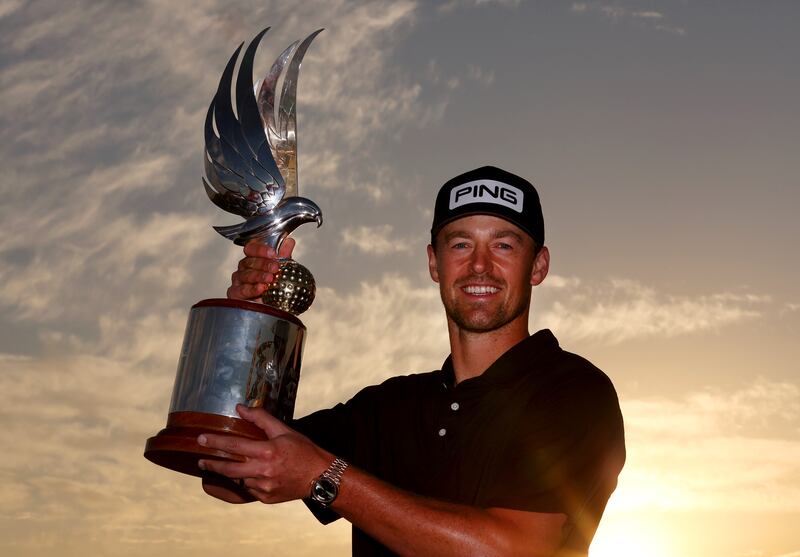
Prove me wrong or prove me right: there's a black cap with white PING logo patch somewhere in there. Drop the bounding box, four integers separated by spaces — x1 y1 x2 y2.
431 166 544 246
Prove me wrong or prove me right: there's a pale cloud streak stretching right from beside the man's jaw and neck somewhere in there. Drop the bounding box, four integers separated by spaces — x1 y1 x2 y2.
534 277 771 343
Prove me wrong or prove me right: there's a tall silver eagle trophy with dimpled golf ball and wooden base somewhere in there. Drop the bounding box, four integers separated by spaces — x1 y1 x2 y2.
144 28 322 476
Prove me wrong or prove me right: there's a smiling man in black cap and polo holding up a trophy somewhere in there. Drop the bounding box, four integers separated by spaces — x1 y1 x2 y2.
198 163 625 556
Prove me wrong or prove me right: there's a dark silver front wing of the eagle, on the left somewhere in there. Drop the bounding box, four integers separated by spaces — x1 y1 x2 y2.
203 28 286 218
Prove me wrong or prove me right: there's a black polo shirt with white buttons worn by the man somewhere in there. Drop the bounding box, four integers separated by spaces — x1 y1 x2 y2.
295 330 625 556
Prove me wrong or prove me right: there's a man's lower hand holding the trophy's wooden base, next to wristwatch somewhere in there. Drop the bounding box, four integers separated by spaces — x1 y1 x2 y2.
197 404 334 503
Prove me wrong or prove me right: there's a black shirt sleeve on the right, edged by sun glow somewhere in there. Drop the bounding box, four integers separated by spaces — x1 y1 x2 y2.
487 370 625 533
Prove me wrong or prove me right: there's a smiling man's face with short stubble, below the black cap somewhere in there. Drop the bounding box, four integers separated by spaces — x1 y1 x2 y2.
428 215 549 332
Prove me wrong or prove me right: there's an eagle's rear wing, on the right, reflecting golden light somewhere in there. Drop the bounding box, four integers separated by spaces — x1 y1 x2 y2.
257 29 323 197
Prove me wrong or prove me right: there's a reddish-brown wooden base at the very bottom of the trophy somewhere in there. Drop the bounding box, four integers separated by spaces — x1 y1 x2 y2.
144 412 267 477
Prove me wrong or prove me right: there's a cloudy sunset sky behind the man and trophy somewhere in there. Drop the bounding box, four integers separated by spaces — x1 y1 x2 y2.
0 0 800 557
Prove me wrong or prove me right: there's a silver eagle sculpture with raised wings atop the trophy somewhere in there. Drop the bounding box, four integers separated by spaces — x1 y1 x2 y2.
203 27 322 250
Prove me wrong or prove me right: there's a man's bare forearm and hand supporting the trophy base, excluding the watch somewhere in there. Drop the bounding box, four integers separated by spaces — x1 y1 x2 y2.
198 406 566 556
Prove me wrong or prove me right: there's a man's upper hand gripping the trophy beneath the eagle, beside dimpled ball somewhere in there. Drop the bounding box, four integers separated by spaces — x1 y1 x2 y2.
228 238 294 300
